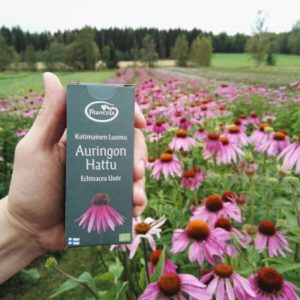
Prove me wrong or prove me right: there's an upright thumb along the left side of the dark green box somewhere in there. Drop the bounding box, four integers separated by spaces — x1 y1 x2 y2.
26 72 66 147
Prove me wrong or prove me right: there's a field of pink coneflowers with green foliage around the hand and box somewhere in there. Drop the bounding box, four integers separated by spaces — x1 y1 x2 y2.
0 68 300 300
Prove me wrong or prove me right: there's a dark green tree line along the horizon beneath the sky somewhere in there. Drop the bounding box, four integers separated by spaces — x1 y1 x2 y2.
0 22 300 70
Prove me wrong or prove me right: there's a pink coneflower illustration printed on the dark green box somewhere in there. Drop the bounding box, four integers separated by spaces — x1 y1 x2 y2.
75 193 125 234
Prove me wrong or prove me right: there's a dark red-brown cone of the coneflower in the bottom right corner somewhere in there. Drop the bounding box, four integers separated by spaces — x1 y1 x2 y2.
256 268 283 293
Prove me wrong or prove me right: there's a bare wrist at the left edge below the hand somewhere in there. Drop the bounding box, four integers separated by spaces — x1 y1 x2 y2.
0 197 44 284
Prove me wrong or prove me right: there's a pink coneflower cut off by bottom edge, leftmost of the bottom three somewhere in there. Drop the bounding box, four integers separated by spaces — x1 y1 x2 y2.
139 273 211 300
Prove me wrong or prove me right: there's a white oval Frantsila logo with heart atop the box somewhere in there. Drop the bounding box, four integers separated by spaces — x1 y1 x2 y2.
84 101 119 123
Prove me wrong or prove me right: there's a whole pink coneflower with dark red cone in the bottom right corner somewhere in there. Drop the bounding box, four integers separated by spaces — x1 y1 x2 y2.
246 268 300 300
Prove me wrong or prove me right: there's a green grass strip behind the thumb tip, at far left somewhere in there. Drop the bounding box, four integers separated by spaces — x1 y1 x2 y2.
0 71 115 98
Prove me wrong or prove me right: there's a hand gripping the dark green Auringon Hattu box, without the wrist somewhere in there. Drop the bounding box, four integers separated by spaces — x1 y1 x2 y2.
2 73 147 252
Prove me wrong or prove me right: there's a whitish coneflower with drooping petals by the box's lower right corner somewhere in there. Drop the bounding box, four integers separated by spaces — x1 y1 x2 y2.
128 217 166 258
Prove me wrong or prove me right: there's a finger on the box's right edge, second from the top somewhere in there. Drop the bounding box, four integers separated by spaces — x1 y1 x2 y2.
133 128 147 180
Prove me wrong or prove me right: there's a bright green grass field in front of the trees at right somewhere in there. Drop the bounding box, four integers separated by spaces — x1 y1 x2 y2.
168 53 300 87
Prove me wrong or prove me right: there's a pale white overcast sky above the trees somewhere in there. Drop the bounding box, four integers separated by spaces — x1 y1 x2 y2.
0 0 300 34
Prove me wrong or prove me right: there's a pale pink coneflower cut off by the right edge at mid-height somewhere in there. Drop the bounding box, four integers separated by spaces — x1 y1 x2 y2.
278 135 300 174
